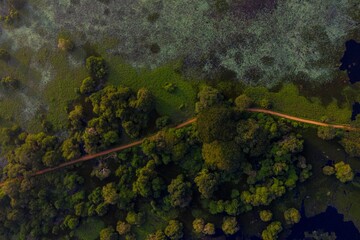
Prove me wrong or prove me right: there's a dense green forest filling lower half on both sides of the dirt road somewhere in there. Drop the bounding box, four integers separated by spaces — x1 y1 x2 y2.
0 56 360 240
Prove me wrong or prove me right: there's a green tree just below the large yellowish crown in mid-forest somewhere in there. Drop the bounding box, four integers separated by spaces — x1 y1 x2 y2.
194 168 219 199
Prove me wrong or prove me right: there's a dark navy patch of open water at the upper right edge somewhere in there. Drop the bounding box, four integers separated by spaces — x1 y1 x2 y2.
340 40 360 84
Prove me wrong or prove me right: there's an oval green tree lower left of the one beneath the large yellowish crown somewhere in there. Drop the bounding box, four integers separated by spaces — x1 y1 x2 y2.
168 175 192 208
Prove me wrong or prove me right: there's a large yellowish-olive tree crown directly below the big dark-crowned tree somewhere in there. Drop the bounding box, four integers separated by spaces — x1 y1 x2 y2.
202 141 242 172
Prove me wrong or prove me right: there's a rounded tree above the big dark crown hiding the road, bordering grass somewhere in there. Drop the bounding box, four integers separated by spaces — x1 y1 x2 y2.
195 86 223 113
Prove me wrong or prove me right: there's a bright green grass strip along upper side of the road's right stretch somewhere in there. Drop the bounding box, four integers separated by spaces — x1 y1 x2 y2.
245 84 351 124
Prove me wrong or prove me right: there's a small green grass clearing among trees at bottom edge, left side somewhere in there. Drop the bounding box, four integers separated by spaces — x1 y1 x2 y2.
75 218 105 240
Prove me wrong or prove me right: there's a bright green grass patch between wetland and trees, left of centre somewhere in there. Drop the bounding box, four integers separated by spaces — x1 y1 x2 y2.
107 57 196 120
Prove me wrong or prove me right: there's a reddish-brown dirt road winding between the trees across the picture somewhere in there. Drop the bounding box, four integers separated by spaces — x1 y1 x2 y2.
0 108 360 187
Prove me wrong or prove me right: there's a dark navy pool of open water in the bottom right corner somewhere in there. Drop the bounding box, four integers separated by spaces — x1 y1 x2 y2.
286 206 360 240
